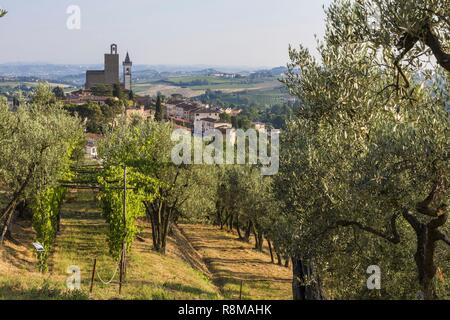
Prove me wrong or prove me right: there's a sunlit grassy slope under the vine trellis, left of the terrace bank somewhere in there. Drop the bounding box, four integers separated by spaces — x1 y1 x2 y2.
0 192 220 299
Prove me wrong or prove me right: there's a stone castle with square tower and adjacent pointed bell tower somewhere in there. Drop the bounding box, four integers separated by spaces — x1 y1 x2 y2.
85 44 133 91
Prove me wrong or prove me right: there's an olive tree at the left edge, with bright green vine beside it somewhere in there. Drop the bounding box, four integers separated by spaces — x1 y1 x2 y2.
0 84 83 269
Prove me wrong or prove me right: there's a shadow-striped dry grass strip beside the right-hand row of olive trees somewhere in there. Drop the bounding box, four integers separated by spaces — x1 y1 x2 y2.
180 225 292 300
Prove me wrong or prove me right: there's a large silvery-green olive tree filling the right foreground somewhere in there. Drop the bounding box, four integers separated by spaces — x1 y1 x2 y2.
275 1 450 299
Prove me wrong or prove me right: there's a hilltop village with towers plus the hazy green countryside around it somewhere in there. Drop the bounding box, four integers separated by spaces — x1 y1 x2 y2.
0 44 288 158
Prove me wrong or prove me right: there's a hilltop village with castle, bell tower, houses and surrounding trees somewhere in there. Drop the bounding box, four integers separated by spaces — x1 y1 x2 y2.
32 44 282 158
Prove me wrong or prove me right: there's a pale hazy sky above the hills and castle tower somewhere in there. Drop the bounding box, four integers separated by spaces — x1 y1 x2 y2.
0 0 330 67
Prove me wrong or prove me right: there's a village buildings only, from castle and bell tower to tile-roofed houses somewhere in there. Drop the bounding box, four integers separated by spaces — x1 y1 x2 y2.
62 44 272 140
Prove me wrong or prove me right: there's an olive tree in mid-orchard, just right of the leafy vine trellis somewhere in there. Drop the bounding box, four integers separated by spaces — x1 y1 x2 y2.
100 120 214 254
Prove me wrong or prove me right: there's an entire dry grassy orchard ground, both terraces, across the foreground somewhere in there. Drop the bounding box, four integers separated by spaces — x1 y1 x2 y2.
0 191 290 299
